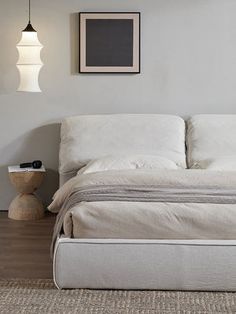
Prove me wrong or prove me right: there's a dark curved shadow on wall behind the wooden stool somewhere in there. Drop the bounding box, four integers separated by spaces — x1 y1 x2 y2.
0 123 60 210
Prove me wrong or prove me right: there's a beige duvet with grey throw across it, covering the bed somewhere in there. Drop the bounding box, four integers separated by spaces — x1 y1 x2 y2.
49 169 236 253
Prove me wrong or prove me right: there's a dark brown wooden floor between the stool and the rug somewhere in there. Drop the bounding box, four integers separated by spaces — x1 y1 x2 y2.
0 212 55 279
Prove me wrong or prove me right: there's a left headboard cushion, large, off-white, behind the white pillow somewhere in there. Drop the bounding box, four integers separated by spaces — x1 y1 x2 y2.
59 114 186 185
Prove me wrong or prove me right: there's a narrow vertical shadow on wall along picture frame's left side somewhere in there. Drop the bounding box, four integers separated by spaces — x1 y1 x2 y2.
70 13 79 75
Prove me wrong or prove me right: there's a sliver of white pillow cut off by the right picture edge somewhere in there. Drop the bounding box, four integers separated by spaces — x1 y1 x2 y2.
192 155 236 171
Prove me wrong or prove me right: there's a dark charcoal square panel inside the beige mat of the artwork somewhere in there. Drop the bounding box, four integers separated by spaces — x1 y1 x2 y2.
86 19 133 67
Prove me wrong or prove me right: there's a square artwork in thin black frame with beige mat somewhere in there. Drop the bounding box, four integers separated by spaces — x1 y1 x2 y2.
79 12 140 73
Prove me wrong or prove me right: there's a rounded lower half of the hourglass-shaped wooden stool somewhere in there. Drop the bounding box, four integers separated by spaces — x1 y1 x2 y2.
8 194 44 220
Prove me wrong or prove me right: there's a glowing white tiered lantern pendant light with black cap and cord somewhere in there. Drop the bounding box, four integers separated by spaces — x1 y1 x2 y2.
16 0 43 92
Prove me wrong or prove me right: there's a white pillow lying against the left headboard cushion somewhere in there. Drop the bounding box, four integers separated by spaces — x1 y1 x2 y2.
77 155 180 174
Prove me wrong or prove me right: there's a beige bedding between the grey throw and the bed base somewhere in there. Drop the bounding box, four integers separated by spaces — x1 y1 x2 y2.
63 201 236 239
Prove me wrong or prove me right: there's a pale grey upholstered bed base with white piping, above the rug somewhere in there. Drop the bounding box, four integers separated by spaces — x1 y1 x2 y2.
53 236 236 291
